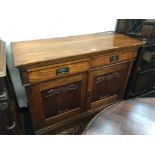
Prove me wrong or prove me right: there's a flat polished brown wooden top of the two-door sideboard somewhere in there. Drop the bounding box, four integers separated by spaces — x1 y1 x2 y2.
11 32 143 68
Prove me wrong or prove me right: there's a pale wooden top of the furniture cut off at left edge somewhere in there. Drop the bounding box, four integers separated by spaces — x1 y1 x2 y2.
0 40 6 77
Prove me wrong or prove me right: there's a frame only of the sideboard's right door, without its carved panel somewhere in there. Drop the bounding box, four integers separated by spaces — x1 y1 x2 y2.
87 62 132 109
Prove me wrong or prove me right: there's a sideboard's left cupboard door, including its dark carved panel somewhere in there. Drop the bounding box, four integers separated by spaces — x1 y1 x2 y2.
27 74 87 131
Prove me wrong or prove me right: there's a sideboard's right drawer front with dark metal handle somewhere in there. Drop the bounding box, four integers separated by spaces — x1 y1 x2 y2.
91 50 137 67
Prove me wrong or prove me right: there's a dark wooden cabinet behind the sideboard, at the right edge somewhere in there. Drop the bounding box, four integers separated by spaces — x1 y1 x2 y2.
116 19 155 99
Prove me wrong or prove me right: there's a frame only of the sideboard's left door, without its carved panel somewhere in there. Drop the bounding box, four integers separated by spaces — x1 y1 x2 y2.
27 73 87 131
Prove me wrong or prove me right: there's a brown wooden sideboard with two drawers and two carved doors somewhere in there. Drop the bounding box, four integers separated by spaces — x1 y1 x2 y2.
11 32 143 134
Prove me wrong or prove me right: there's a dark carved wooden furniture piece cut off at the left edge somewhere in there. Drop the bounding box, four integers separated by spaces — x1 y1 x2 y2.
0 40 22 135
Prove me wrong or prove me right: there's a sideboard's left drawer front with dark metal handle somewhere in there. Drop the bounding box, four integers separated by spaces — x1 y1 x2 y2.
27 61 89 84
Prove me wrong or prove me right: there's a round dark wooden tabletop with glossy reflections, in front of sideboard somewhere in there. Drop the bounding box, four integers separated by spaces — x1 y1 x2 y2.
83 98 155 135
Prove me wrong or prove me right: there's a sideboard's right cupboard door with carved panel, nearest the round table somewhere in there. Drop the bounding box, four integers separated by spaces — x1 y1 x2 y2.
87 63 129 109
